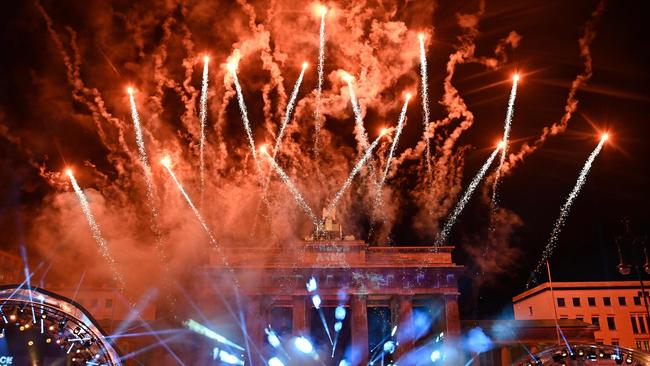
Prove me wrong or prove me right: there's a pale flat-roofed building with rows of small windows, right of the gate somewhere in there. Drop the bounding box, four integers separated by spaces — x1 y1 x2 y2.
512 281 650 351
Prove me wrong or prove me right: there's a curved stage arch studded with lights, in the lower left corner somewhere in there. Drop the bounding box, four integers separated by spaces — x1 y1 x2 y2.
0 284 121 366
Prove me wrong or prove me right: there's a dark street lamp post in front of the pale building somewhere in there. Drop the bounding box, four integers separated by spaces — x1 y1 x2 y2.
614 220 650 319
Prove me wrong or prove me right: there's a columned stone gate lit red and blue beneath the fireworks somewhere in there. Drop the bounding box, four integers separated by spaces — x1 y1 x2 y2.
201 239 462 365
